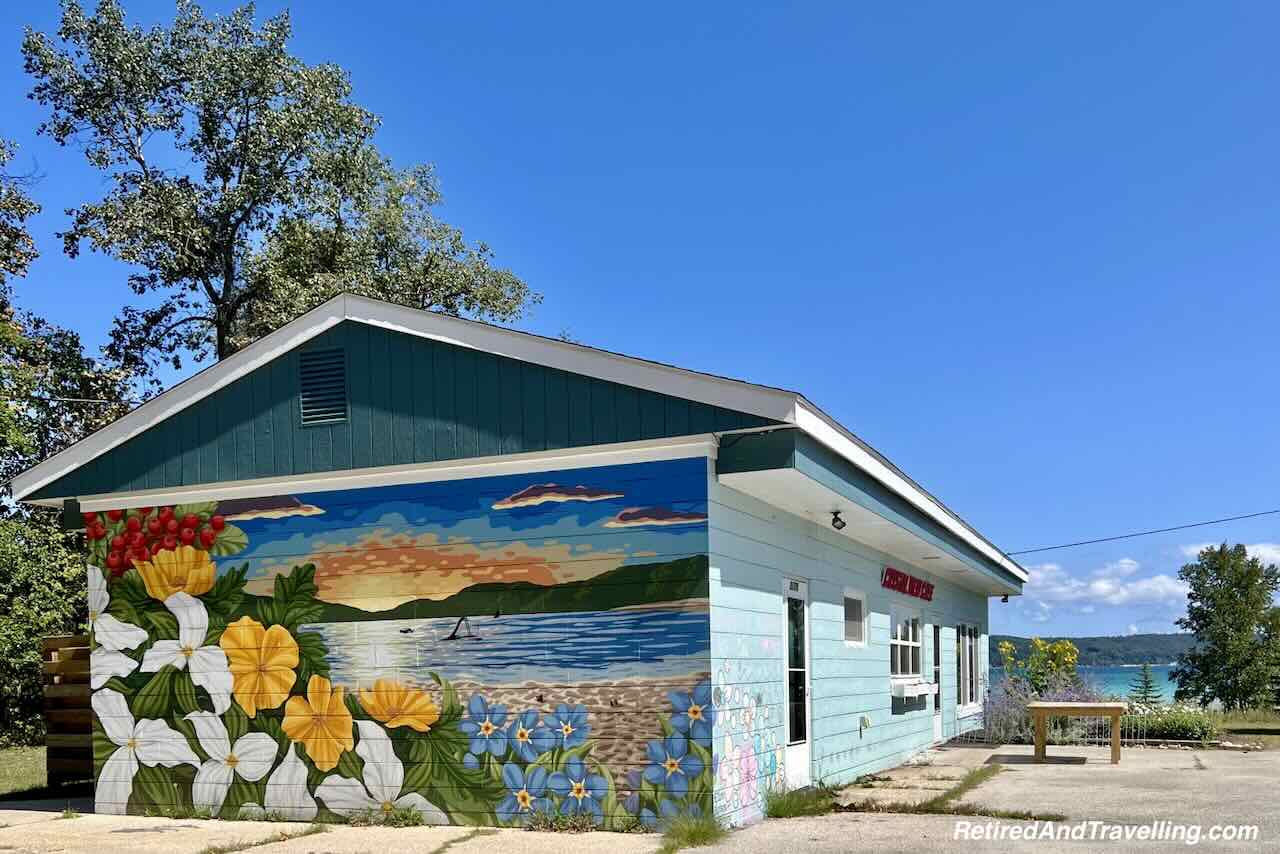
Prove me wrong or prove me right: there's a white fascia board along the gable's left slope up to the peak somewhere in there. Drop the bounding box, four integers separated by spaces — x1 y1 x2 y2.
10 294 346 503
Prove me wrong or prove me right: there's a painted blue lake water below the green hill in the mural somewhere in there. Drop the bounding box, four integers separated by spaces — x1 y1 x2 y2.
306 609 709 686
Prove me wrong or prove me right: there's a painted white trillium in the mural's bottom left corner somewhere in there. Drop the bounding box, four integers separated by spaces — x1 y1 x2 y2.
90 689 200 816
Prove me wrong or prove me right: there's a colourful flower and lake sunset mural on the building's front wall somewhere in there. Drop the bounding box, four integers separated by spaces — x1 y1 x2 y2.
84 458 717 830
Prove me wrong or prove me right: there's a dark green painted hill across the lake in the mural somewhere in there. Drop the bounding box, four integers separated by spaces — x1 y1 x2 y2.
249 554 709 622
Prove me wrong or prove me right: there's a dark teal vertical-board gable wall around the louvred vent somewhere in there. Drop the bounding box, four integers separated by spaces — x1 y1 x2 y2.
32 320 771 499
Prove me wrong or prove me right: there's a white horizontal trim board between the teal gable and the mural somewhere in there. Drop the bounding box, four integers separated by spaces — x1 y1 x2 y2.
38 434 717 512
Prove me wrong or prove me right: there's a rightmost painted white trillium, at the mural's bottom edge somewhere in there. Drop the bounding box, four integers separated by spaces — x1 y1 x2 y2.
316 721 449 825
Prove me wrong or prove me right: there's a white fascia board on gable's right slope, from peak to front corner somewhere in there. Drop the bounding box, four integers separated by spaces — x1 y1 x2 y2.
347 294 799 423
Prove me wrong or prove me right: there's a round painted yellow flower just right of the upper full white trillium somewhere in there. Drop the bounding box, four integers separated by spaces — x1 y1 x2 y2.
218 617 298 717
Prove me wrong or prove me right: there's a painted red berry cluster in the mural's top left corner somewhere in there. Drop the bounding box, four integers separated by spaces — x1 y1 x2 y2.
84 507 227 576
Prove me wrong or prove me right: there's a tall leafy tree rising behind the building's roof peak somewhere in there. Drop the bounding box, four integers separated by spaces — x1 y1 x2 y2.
22 0 539 383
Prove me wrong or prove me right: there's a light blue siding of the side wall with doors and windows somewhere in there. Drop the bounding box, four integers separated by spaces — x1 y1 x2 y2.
709 481 987 825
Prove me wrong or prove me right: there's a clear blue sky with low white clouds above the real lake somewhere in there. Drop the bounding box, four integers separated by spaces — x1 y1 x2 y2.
0 0 1280 635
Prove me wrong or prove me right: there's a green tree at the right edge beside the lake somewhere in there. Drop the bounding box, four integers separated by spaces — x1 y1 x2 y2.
1172 543 1280 709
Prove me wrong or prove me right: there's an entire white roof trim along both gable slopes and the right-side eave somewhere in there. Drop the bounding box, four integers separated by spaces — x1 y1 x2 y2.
10 293 1027 581
